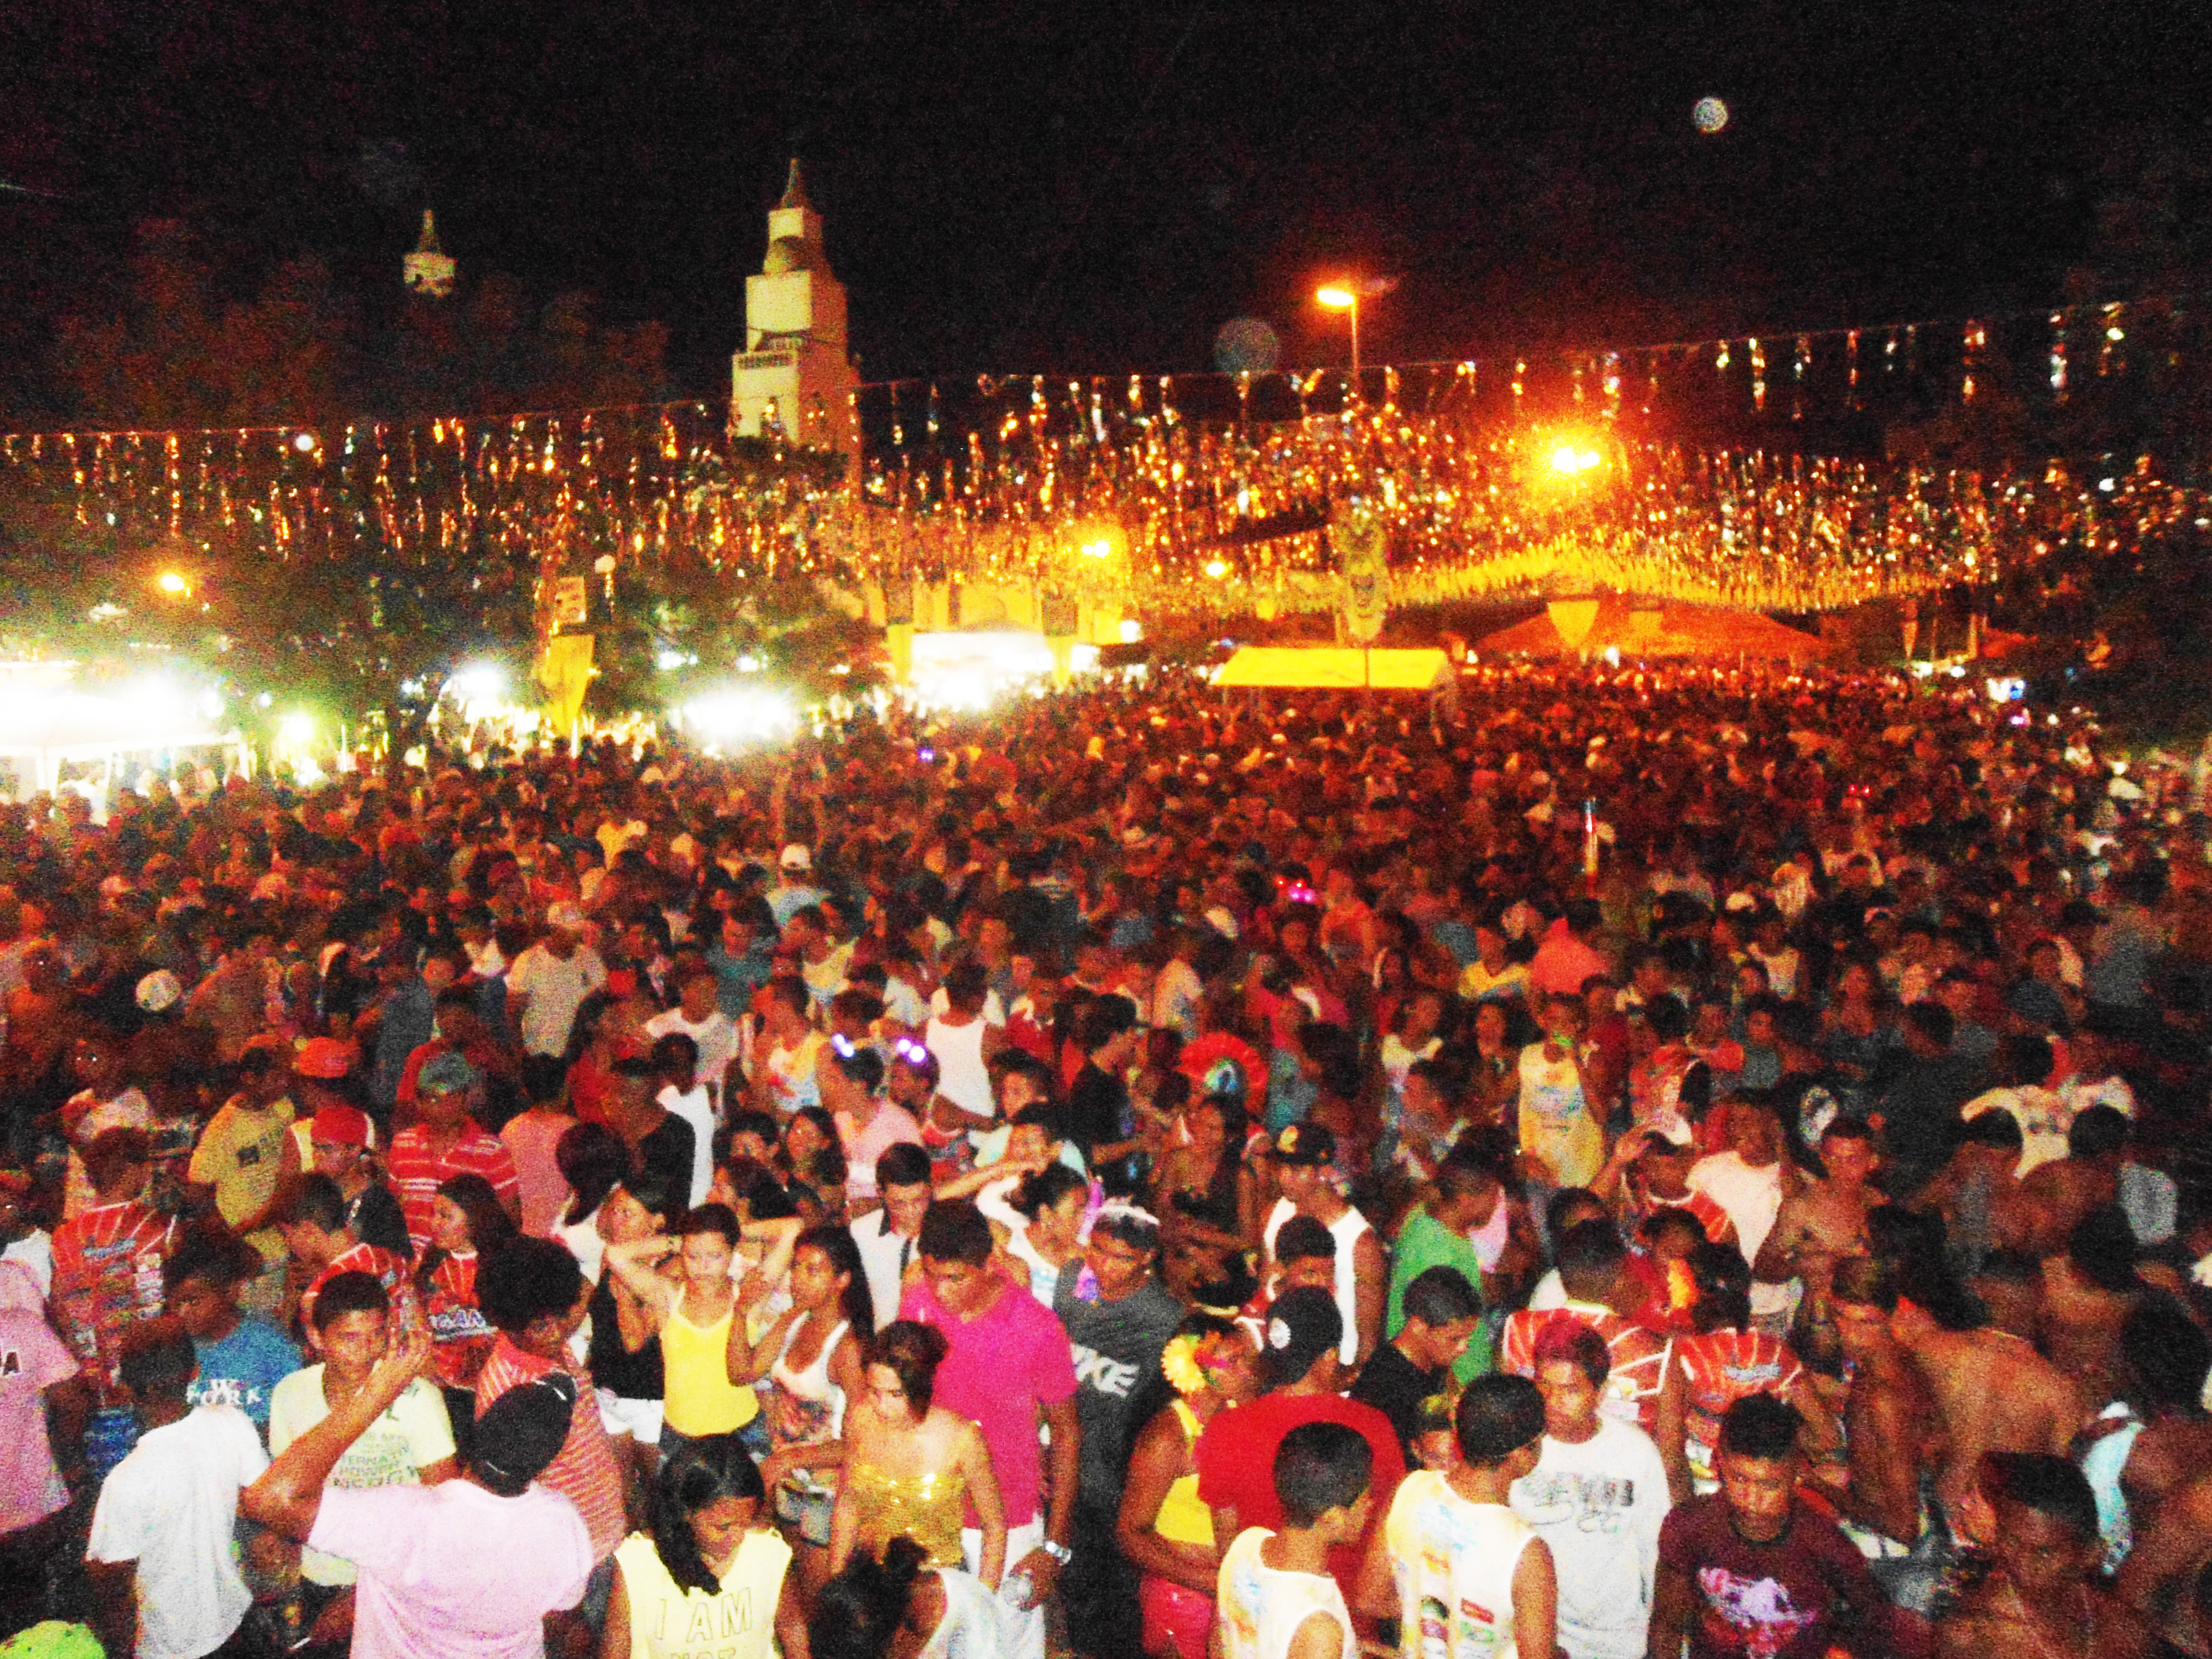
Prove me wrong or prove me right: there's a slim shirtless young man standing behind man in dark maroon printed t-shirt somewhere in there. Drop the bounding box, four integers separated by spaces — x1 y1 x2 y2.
1827 1256 1944 1544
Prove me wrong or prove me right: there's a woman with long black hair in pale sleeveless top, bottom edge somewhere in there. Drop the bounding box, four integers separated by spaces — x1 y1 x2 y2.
599 1433 805 1659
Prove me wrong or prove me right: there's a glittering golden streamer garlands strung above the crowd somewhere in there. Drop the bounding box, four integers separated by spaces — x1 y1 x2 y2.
0 290 2212 615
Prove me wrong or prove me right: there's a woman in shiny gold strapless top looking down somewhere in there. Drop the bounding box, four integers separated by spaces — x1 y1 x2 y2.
830 1318 1006 1590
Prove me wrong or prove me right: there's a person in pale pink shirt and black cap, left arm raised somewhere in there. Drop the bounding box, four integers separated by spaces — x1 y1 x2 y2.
239 1329 593 1659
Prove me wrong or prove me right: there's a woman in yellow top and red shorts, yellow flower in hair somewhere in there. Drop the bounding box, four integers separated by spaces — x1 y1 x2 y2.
1115 1314 1259 1659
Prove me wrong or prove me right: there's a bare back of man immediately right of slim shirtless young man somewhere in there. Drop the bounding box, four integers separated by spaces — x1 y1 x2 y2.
1889 1274 2088 1542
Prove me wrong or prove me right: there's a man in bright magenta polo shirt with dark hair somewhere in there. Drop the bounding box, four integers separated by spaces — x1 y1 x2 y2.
898 1199 1084 1659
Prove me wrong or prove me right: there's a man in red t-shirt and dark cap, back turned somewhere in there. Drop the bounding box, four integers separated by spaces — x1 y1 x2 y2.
1197 1285 1407 1606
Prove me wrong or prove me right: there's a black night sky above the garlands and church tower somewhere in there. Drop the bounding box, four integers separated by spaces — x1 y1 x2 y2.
0 0 2212 394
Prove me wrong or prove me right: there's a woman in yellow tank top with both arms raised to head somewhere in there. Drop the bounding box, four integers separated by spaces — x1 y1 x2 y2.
606 1203 803 1453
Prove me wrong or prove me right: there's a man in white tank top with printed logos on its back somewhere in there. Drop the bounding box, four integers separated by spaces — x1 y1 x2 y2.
1360 1376 1559 1659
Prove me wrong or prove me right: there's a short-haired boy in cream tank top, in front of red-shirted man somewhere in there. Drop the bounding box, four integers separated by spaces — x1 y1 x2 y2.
1214 1422 1374 1659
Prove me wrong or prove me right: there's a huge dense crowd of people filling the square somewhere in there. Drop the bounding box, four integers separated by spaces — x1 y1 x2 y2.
0 664 2212 1659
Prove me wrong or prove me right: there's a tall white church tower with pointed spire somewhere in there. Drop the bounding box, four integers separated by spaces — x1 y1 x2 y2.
730 159 860 469
